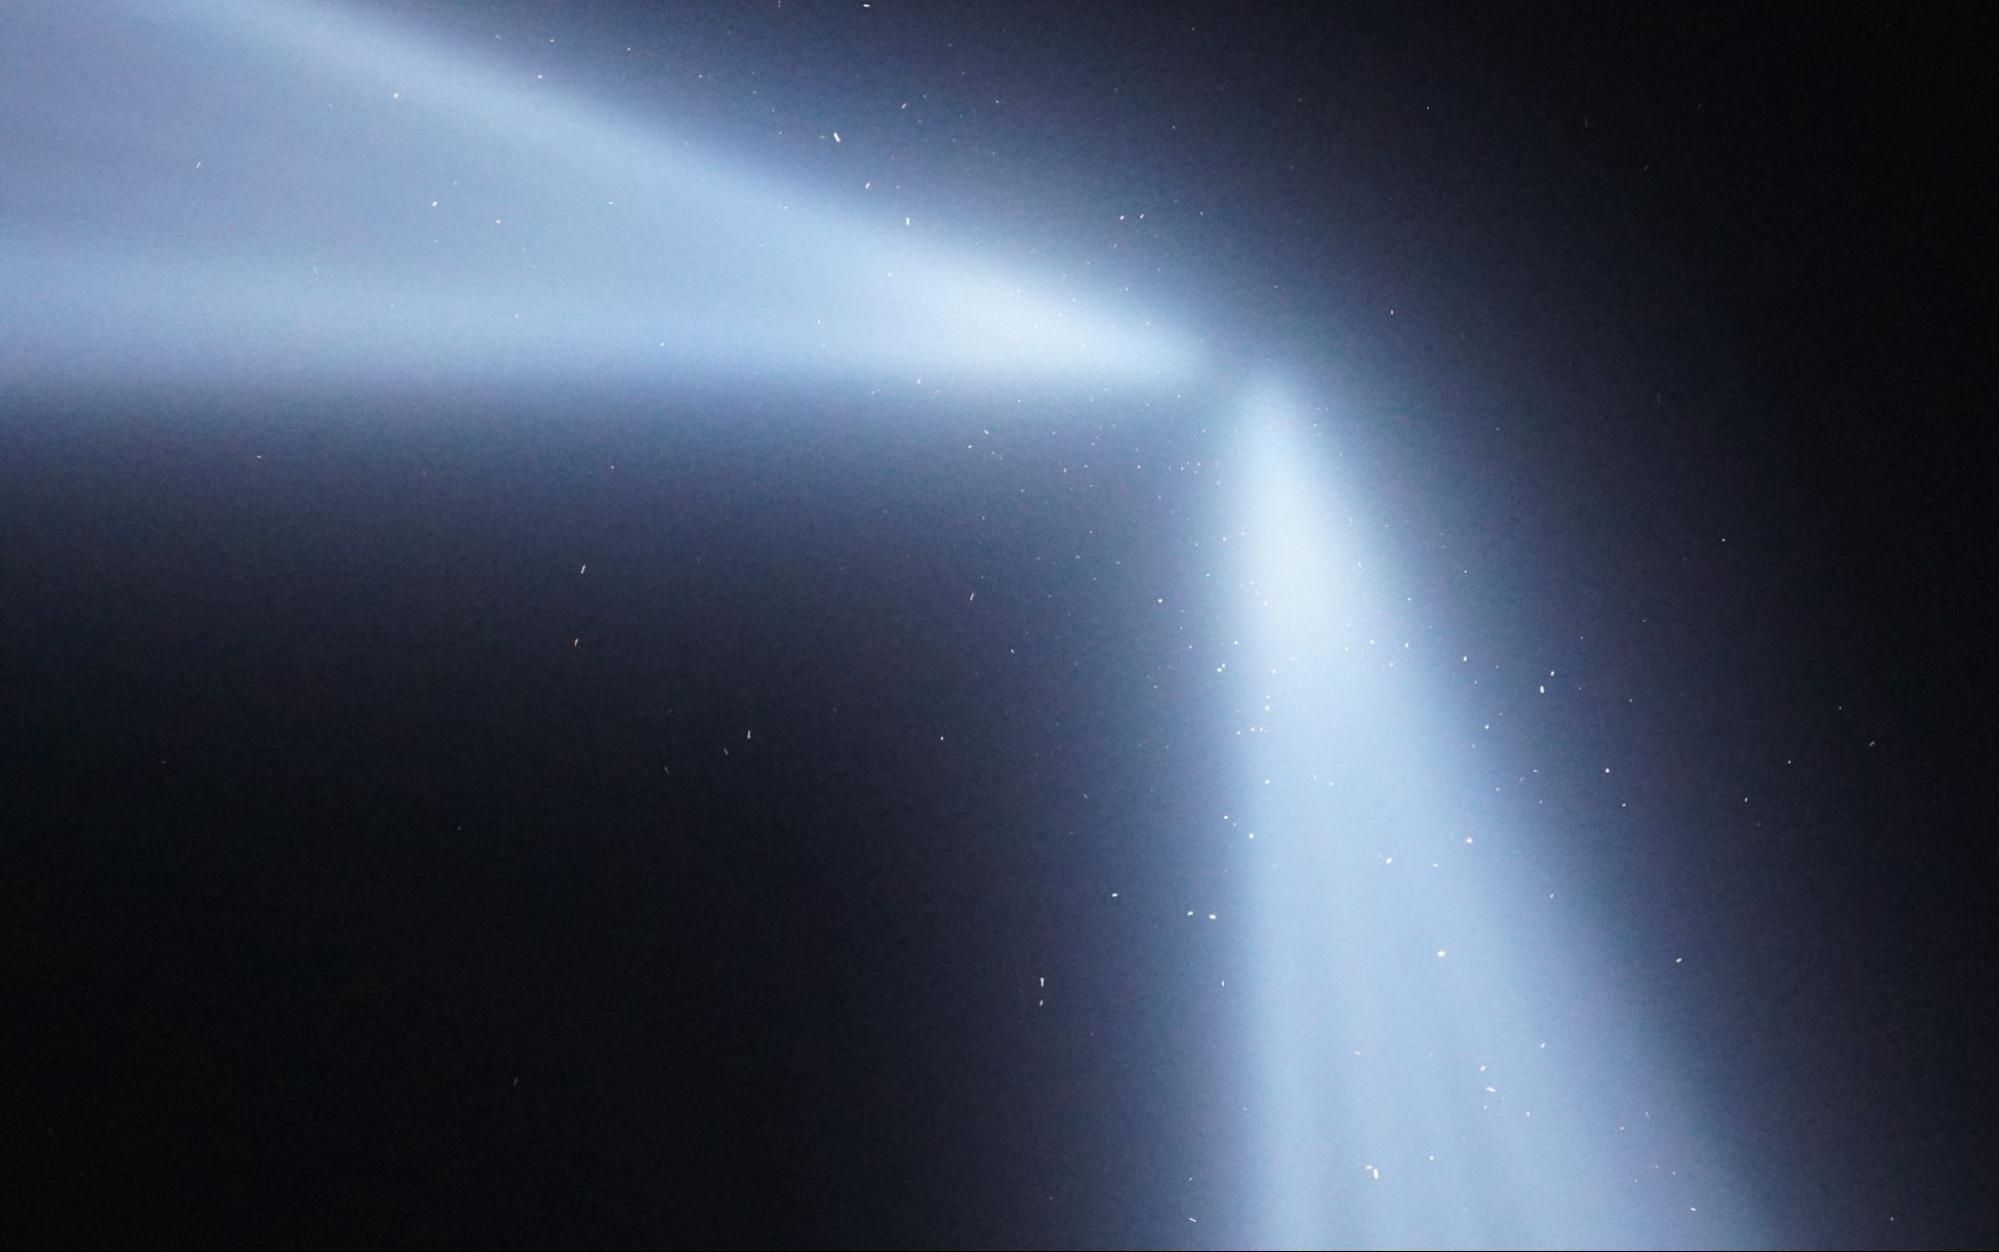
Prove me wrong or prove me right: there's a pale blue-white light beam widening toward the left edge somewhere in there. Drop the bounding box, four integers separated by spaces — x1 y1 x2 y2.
0 0 1193 384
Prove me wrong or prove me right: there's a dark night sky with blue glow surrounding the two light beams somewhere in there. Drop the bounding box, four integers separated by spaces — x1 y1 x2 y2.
0 2 1999 1246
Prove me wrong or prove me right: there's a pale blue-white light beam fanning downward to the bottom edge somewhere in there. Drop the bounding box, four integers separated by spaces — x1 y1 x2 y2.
1225 392 1755 1248
